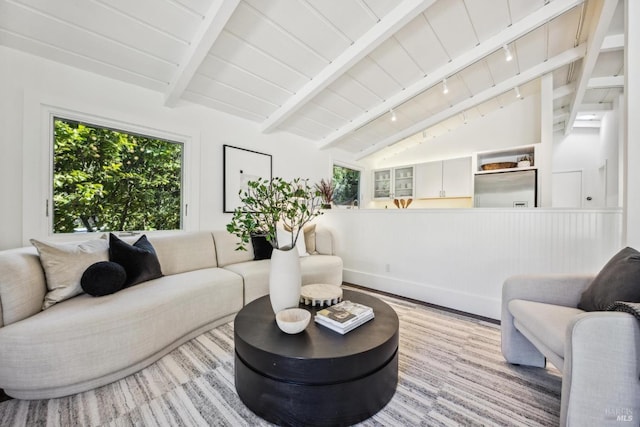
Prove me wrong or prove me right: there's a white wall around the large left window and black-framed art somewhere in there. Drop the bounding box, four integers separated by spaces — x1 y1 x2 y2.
0 47 332 249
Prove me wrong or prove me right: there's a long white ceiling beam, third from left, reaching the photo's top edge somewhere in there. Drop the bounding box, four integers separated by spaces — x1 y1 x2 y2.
318 0 584 148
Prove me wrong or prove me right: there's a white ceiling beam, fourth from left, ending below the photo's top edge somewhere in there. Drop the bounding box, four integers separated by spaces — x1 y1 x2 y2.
356 45 586 160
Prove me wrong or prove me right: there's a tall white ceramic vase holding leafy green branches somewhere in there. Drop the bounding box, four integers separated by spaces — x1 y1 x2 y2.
269 247 302 313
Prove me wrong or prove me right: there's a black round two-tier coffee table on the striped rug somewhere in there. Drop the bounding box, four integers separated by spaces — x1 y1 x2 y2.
234 290 398 426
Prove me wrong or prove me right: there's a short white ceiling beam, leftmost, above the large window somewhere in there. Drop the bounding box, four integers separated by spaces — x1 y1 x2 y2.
164 0 240 107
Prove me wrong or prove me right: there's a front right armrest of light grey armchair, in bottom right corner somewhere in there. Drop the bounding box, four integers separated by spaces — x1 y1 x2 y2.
560 311 640 426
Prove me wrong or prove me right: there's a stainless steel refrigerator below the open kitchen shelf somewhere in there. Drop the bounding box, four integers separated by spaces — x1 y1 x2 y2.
473 169 538 208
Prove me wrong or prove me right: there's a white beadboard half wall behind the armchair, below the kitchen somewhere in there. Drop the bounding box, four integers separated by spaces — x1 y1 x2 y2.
318 208 622 319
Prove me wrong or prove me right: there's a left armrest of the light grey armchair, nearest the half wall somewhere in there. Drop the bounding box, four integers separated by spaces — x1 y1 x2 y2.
500 274 594 367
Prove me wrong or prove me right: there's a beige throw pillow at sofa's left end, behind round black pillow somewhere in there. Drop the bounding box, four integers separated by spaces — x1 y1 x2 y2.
31 239 109 310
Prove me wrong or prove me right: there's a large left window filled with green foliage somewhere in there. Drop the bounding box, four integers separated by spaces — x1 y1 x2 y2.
53 117 184 233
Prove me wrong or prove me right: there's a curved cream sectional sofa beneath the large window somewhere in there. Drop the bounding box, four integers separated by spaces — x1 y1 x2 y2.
0 228 342 399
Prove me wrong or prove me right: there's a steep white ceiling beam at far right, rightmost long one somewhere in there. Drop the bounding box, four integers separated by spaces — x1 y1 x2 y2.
564 0 618 135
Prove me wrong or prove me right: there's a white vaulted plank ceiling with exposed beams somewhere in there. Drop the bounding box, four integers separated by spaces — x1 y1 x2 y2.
0 0 624 159
